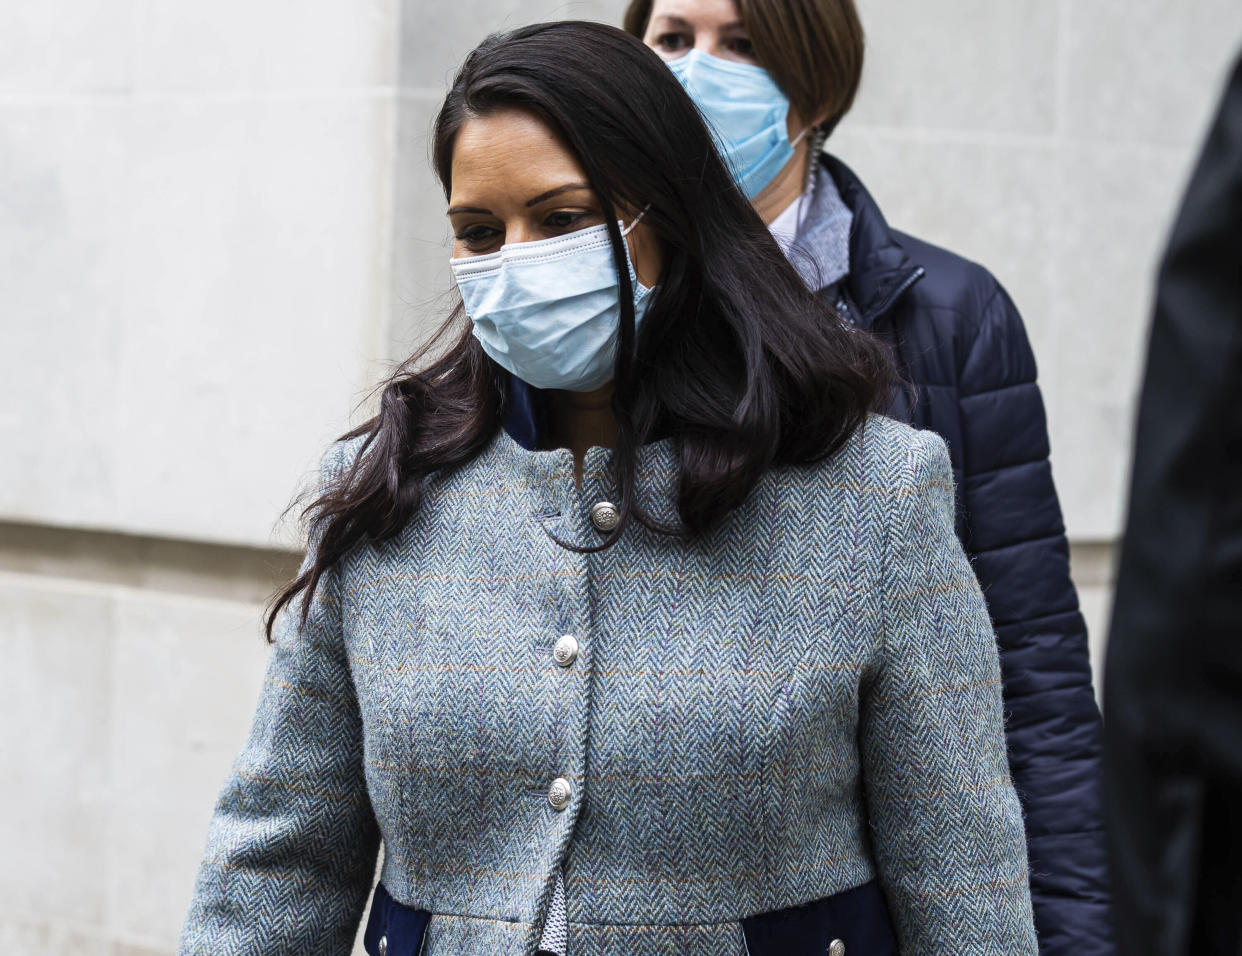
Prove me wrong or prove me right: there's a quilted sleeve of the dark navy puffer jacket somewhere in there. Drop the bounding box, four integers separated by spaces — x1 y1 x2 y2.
959 283 1114 956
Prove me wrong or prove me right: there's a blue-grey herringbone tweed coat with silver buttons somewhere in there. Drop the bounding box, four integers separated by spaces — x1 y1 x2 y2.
181 417 1036 956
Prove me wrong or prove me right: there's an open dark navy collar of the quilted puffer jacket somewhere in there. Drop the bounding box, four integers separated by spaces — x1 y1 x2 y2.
820 154 924 329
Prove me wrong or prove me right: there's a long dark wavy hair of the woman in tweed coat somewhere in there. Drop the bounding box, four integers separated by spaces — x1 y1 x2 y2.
266 22 889 636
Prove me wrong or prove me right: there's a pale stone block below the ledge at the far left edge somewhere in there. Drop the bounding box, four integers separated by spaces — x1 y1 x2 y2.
0 576 116 933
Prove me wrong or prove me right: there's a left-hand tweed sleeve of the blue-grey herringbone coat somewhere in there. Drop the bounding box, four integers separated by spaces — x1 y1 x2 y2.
179 441 379 956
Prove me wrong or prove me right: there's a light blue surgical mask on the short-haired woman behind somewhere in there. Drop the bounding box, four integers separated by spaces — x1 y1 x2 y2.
668 50 806 199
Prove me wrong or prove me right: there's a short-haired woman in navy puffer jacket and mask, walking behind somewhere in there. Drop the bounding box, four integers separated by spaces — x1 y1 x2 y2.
625 0 1114 956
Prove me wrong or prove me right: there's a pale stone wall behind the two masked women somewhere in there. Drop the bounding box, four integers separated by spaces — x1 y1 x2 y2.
0 0 1242 956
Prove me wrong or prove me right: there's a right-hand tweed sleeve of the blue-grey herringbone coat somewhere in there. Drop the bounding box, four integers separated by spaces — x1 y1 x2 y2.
859 432 1036 956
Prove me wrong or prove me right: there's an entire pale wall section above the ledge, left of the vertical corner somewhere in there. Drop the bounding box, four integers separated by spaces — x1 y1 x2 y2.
0 0 409 544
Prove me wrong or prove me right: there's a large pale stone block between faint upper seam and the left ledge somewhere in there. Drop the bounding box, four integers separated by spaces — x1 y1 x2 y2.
0 97 394 544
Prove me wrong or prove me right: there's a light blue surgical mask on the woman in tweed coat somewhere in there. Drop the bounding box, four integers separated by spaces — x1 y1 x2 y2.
450 214 651 391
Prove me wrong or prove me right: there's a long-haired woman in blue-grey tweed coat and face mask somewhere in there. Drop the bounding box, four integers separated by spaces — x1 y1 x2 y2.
181 16 1035 956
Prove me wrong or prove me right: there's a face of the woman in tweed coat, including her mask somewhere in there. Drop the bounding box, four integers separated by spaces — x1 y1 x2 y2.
448 110 660 392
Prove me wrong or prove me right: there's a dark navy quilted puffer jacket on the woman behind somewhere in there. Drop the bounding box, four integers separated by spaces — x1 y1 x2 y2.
819 156 1114 956
